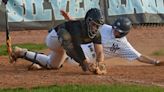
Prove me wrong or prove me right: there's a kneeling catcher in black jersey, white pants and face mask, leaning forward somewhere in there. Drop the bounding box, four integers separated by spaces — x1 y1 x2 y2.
12 8 105 74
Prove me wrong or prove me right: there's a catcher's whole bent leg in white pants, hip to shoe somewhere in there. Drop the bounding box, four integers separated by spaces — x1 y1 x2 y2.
12 30 66 69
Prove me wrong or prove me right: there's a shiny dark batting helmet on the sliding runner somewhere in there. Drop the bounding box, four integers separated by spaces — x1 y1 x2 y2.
112 17 132 38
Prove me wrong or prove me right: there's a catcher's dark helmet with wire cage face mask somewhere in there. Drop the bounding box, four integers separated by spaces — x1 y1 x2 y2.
85 8 104 38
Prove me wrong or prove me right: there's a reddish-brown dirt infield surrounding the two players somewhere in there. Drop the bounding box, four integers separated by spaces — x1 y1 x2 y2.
0 27 164 88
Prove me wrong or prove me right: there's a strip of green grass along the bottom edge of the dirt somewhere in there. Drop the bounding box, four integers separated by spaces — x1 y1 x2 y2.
0 84 164 92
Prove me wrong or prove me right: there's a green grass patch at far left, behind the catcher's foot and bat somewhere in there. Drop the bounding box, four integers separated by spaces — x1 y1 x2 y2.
0 43 47 56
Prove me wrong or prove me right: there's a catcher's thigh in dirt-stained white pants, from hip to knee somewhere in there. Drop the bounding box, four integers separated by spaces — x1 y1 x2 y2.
46 29 67 69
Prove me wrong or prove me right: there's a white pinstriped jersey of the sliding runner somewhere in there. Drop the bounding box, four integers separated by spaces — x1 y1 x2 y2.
100 24 141 60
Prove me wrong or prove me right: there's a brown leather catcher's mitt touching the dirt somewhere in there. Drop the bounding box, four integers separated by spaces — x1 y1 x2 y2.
88 62 107 75
